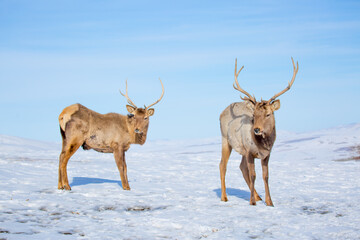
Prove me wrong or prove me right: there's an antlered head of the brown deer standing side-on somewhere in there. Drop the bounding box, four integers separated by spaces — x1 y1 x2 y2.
120 78 164 144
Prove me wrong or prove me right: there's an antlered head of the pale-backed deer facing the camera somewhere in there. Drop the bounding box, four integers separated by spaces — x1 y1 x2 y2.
233 58 299 138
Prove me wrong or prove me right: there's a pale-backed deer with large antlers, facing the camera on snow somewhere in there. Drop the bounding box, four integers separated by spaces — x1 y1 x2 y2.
219 58 299 206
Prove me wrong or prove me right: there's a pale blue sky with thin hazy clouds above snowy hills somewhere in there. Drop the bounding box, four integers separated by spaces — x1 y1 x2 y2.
0 0 360 142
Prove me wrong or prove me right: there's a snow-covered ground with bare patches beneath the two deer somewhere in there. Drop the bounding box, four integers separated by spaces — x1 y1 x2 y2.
0 124 360 239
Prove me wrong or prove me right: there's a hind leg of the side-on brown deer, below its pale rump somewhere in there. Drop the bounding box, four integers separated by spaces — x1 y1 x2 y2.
58 142 81 190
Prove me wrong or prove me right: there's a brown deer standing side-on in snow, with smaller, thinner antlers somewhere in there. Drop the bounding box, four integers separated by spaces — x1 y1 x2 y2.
58 79 164 190
